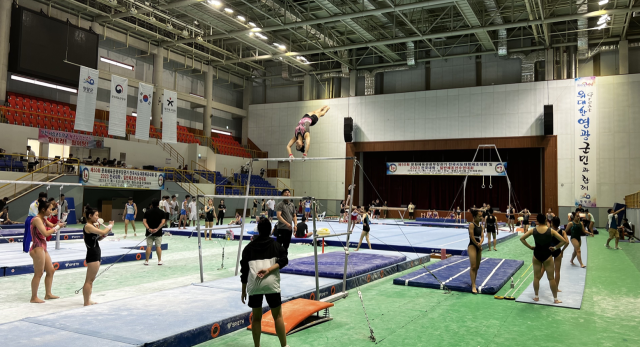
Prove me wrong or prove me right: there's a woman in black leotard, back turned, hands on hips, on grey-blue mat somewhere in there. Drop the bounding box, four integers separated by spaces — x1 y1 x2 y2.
520 213 567 304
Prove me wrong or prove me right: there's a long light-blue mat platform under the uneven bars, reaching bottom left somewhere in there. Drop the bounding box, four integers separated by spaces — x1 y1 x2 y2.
0 251 429 347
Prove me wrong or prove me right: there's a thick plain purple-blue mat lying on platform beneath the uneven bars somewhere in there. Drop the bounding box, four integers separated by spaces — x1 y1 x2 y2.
280 252 407 278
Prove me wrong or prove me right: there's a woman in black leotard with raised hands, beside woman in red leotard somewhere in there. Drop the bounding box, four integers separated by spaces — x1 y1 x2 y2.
82 207 114 306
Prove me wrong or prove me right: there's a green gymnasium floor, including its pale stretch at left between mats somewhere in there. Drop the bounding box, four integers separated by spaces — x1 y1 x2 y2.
0 223 640 347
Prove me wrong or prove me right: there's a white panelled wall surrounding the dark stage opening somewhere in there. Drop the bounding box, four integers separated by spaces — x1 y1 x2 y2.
249 75 640 206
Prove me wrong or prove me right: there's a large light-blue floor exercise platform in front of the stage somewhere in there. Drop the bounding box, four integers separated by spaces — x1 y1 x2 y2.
164 222 516 255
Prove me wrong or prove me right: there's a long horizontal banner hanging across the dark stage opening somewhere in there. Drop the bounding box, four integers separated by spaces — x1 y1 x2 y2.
387 162 507 176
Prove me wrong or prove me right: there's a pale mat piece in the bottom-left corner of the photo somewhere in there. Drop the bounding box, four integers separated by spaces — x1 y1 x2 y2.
0 321 132 347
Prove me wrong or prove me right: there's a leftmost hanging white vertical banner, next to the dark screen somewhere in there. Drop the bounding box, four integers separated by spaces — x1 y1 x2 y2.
73 66 99 133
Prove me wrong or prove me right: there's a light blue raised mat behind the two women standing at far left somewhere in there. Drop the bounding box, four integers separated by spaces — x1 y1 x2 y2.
0 239 169 277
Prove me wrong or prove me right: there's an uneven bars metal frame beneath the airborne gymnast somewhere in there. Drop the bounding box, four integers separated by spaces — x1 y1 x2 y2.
195 157 357 300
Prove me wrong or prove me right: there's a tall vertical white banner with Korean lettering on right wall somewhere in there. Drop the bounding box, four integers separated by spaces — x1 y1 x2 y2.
574 77 598 207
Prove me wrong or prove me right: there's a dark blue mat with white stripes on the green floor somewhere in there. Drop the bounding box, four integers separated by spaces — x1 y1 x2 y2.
393 256 524 294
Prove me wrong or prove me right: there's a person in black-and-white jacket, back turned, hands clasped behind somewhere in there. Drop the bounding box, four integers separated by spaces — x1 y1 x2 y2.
240 219 293 347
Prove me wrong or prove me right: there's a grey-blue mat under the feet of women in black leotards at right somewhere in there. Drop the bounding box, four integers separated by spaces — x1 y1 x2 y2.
516 236 588 310
